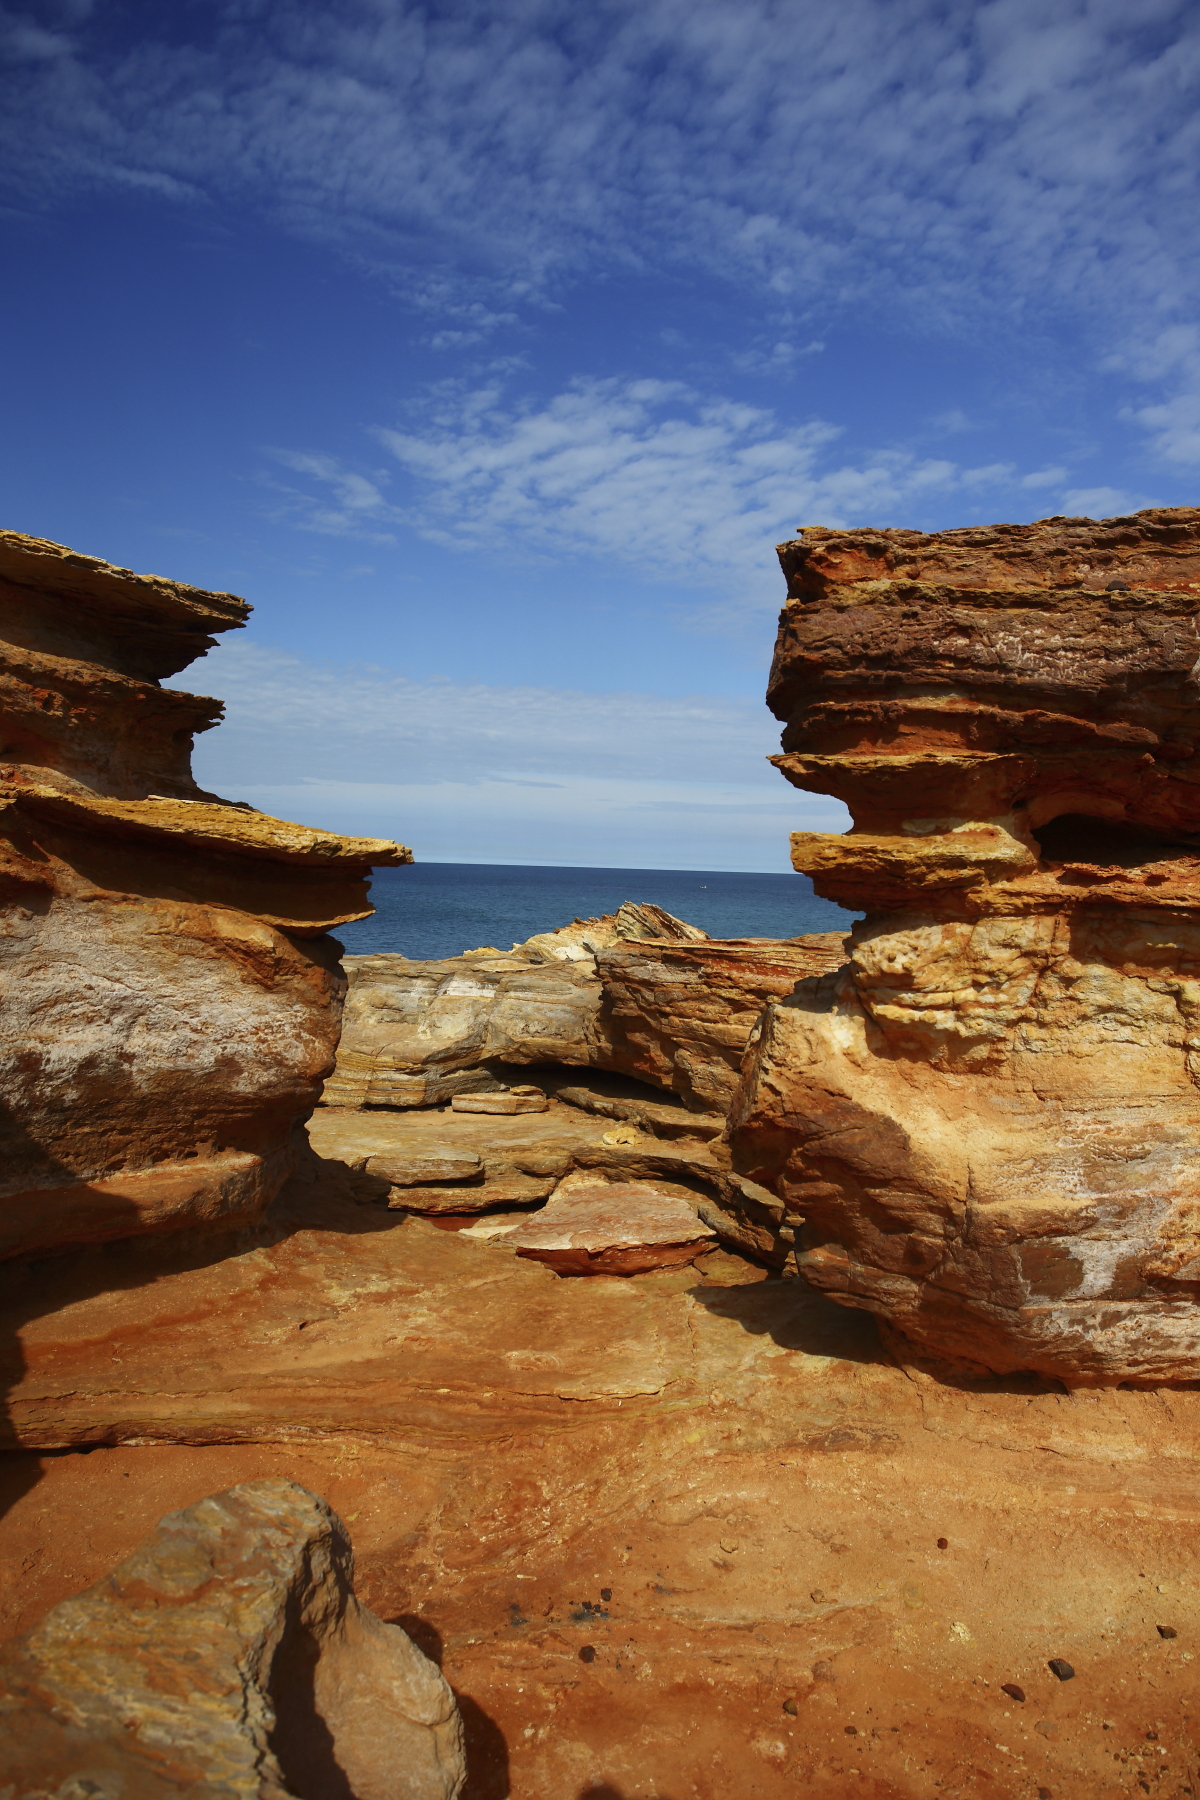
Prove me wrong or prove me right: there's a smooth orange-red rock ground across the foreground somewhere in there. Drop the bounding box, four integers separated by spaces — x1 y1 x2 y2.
0 1114 1200 1800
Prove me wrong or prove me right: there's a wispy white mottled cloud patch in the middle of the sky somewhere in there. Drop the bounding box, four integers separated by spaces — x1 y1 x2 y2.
255 380 1101 608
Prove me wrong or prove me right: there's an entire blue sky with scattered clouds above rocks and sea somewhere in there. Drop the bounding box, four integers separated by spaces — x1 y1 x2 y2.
0 0 1200 869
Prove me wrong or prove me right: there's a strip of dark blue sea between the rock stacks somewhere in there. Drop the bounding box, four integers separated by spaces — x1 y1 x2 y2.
338 862 858 958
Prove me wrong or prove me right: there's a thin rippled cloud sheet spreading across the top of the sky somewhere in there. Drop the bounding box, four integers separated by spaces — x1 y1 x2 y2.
7 0 1200 331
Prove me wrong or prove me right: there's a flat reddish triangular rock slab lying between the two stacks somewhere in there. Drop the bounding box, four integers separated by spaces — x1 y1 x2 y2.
497 1181 716 1274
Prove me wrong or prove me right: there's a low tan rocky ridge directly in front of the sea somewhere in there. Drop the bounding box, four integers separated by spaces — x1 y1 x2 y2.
324 905 844 1112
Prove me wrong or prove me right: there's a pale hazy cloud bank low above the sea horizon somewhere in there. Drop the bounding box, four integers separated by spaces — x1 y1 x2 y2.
187 641 847 869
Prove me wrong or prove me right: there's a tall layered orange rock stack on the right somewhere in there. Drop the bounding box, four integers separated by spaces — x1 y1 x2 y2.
732 508 1200 1382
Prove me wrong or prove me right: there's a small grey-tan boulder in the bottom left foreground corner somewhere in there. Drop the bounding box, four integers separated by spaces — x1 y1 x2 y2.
0 1478 466 1800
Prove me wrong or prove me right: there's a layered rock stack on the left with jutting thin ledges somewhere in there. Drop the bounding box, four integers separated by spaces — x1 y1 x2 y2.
0 533 410 1256
